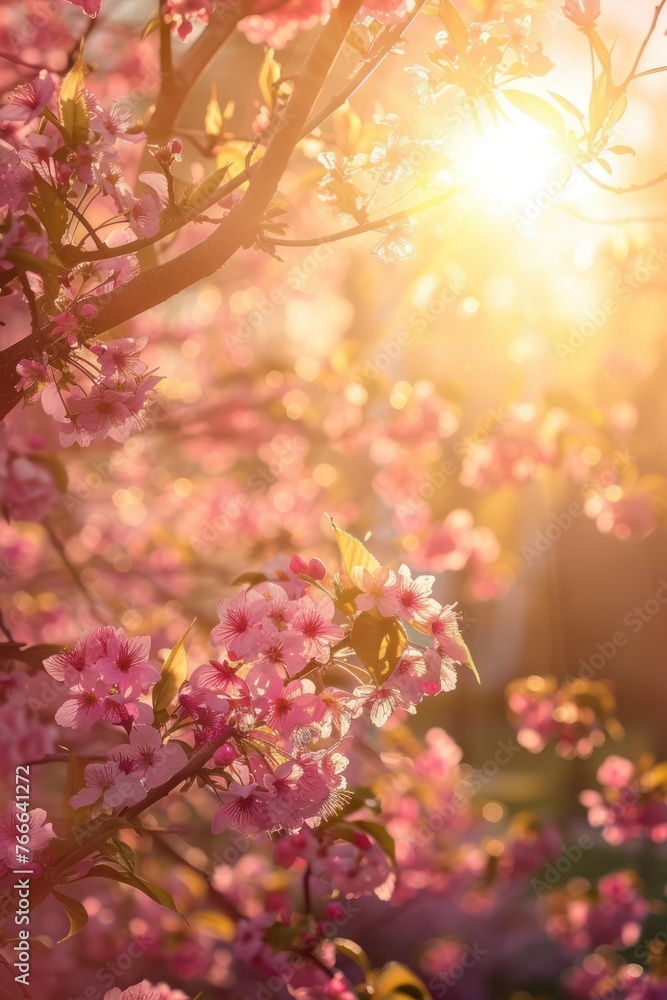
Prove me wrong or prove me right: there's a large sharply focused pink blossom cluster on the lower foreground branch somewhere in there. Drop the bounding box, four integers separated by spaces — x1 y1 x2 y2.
44 544 470 840
